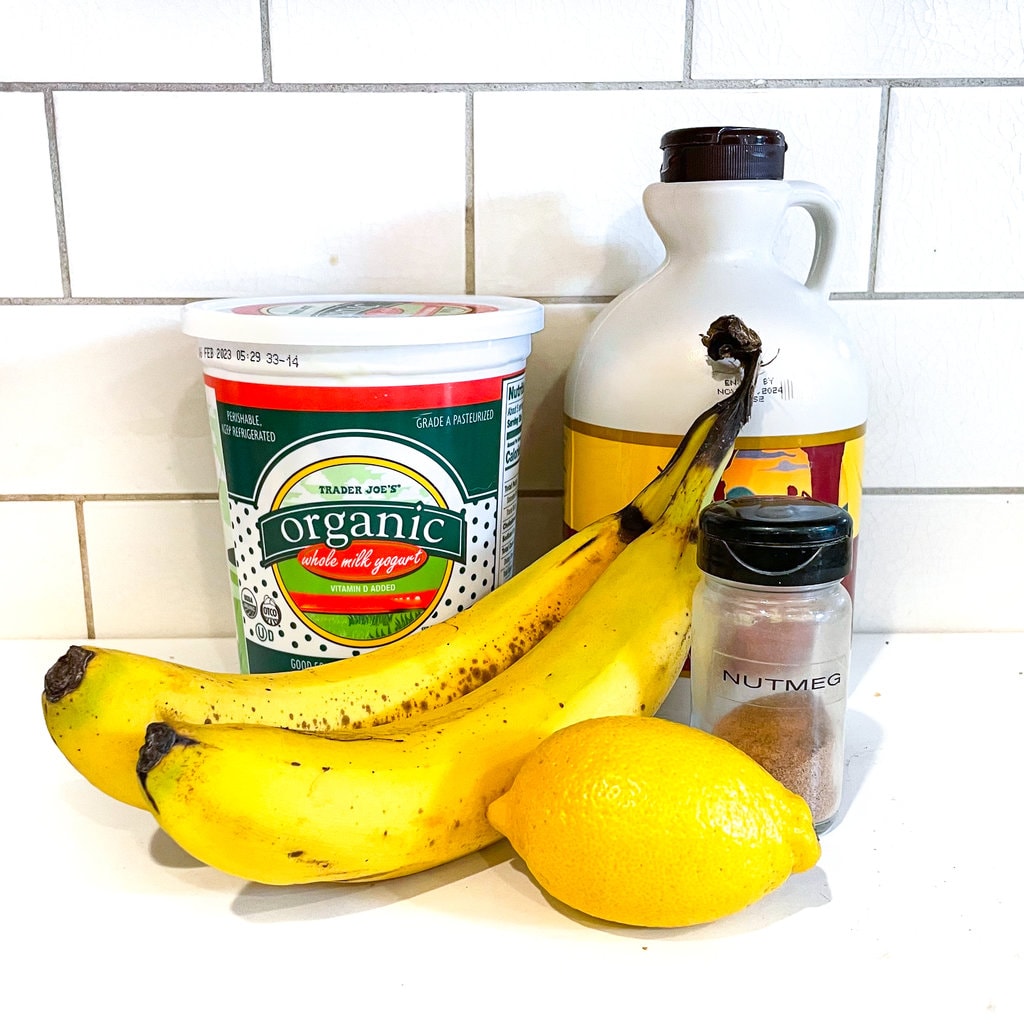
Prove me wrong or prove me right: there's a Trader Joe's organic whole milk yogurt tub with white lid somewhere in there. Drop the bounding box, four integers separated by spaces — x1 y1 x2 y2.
188 295 544 672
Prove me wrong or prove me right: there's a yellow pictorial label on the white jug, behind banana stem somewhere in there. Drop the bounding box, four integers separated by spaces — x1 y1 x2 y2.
564 418 864 535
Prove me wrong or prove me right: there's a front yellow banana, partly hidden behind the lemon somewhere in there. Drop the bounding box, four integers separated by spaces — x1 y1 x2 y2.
138 318 760 885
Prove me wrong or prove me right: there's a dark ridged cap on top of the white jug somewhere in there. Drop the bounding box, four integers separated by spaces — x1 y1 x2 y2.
662 126 786 181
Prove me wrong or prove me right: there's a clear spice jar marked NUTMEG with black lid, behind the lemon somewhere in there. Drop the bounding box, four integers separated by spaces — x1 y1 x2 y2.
690 496 853 834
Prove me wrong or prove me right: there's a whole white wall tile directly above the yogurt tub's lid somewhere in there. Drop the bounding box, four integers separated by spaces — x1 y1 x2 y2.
55 91 466 297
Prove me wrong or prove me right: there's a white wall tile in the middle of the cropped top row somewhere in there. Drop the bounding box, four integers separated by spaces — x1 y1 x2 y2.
270 0 685 83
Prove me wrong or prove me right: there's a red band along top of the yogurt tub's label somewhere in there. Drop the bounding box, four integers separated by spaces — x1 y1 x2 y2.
204 374 502 413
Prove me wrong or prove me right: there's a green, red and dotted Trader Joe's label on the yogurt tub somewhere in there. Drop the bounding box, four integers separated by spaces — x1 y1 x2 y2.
206 372 524 672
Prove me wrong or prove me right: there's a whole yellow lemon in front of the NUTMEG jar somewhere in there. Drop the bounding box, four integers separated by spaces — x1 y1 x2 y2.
487 716 821 928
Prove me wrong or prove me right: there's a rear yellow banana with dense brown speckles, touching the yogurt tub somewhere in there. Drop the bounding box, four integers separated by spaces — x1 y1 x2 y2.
42 348 736 808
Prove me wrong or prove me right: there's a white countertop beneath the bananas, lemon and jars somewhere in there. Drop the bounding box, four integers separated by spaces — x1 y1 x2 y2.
9 634 1024 1024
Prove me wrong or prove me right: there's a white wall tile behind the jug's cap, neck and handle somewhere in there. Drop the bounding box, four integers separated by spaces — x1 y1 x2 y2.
474 88 881 296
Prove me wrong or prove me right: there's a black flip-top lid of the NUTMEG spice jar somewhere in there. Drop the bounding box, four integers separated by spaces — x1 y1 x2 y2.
697 495 853 587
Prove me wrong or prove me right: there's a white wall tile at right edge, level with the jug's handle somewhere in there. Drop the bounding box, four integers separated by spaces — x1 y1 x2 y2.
876 86 1024 292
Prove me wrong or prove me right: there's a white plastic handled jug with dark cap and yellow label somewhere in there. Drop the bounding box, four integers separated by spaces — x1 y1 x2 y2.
564 127 867 593
